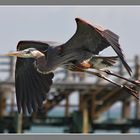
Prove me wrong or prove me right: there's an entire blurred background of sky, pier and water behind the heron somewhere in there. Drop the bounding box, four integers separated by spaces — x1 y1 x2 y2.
0 6 140 133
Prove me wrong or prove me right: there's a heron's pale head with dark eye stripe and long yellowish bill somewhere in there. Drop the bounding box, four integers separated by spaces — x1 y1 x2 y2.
5 48 44 58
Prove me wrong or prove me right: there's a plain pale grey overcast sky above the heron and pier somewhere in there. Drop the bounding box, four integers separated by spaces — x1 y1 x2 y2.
0 6 140 58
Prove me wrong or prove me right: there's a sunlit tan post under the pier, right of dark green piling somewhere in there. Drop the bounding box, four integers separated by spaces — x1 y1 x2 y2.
83 99 89 134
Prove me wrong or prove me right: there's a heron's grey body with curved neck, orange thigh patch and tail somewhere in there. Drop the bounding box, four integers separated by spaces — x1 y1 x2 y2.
26 41 118 74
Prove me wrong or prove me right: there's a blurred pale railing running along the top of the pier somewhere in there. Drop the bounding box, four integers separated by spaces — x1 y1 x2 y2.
0 56 140 83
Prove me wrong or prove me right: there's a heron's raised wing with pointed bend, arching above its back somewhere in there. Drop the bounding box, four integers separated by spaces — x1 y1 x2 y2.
65 18 132 75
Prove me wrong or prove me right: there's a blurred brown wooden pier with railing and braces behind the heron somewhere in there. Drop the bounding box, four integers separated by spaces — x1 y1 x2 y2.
0 56 140 133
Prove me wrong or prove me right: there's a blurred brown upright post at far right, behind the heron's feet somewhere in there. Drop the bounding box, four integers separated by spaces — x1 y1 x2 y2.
134 56 140 119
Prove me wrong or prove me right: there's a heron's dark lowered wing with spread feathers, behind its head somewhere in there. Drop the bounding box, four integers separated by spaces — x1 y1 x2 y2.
15 41 54 113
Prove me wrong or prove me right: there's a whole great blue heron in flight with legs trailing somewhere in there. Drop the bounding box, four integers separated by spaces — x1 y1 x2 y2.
3 18 140 113
